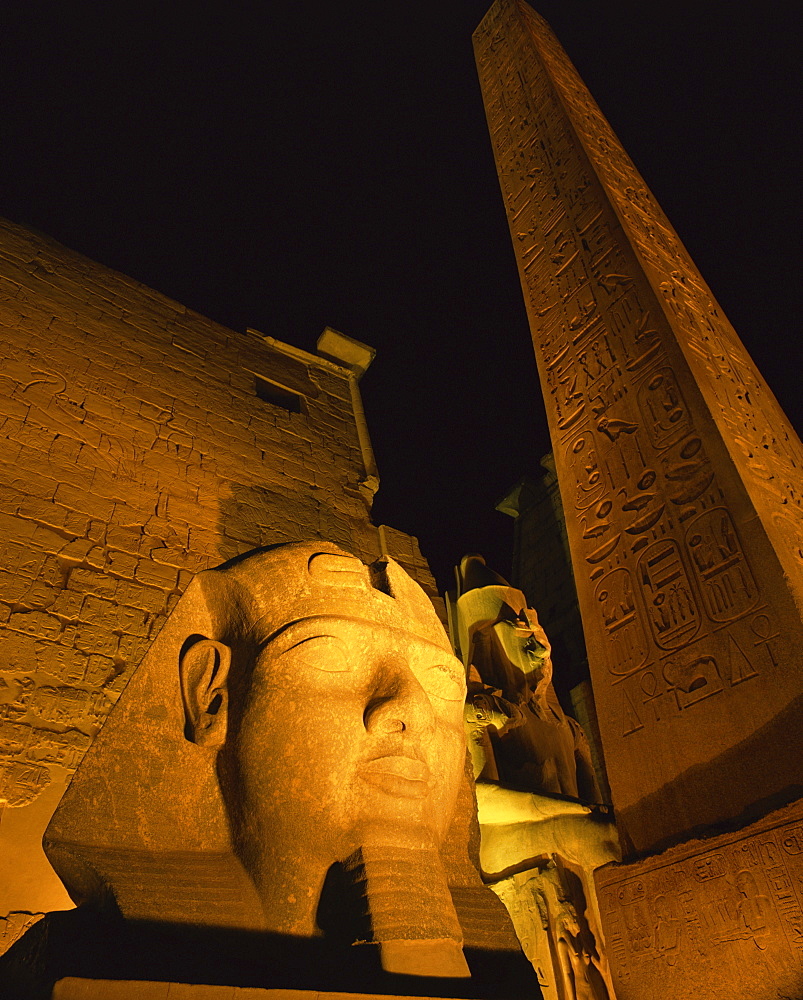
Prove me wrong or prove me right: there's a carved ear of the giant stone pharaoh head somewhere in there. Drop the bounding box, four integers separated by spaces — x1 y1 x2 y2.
179 636 231 747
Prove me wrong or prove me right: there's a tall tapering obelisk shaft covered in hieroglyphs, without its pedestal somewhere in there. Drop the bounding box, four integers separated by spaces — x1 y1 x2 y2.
474 0 803 850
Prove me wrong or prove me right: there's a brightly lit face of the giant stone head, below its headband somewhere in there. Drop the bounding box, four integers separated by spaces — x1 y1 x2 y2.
236 615 465 869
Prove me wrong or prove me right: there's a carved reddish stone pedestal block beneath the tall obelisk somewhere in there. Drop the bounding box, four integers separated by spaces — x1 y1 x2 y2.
596 799 803 1000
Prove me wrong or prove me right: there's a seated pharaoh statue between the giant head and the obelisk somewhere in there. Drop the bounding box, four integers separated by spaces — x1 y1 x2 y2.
457 556 619 1000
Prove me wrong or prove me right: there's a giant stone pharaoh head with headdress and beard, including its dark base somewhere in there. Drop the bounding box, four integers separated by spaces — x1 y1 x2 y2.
3 542 533 997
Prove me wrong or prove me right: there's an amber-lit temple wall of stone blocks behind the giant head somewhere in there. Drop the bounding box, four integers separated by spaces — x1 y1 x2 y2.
0 221 438 952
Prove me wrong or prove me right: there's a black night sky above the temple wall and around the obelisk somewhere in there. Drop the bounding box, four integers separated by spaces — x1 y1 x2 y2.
0 0 803 588
